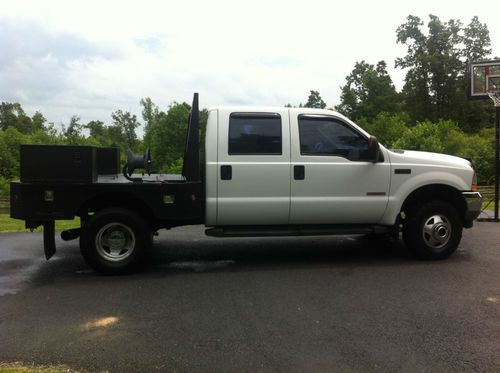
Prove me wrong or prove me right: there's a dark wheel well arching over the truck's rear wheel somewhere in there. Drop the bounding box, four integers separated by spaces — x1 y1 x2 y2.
77 193 154 225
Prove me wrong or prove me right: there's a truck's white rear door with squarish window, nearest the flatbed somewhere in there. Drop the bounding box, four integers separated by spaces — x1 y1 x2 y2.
217 109 290 226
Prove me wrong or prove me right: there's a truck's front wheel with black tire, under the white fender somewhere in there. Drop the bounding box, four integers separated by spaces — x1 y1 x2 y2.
403 201 463 260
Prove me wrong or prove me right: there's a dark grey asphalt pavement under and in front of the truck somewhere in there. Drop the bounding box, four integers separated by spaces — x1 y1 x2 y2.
0 223 500 372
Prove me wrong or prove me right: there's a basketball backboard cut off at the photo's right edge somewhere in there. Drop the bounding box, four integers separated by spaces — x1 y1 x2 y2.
468 60 500 100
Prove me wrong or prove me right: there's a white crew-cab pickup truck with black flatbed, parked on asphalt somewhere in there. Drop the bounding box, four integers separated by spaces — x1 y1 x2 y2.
11 94 481 273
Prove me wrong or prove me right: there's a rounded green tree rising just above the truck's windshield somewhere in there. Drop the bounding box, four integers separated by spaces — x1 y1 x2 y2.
336 61 399 121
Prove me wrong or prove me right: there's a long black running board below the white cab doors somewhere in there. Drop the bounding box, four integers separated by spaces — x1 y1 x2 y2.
205 224 390 237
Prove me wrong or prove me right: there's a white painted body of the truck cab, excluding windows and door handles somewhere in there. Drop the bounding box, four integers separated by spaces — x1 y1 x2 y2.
205 107 474 226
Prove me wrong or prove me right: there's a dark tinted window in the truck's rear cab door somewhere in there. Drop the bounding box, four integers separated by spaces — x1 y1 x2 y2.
228 113 282 155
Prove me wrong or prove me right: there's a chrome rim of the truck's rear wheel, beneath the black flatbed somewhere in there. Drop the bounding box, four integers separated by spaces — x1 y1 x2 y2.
95 222 135 262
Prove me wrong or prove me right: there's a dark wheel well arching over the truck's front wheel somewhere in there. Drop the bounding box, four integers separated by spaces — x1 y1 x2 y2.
401 184 466 217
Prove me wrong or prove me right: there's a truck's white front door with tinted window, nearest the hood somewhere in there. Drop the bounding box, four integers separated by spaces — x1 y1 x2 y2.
290 114 390 224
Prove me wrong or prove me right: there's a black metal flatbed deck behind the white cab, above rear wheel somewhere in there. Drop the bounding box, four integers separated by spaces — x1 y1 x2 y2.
10 174 204 229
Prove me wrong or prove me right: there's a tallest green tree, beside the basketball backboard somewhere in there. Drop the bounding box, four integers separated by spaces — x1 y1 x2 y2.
396 15 491 130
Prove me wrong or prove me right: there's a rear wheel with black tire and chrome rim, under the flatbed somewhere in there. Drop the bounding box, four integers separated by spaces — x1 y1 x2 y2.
80 208 151 275
